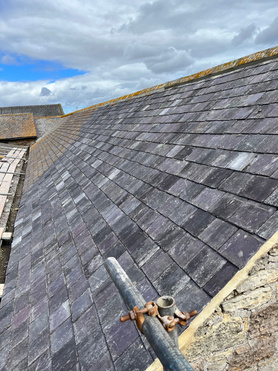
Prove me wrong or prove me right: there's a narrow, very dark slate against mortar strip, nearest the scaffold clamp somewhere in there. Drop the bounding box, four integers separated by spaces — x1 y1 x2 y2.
204 262 238 297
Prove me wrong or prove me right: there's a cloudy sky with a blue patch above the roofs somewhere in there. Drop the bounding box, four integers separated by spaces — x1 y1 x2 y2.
0 0 278 113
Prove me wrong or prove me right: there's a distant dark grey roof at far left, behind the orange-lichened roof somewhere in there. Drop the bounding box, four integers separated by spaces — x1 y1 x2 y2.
0 104 64 117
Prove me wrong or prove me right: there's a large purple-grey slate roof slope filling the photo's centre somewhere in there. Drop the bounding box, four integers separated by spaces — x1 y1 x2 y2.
0 48 278 371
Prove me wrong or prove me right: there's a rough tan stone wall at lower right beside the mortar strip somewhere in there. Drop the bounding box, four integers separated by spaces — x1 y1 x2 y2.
148 235 278 371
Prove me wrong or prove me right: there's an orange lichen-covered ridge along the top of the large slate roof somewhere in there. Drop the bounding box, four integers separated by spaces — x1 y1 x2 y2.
60 46 278 117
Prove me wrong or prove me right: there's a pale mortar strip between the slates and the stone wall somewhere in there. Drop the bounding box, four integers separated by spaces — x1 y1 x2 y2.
146 232 278 371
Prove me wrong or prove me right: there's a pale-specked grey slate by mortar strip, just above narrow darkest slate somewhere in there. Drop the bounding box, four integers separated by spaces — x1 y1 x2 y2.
219 230 263 268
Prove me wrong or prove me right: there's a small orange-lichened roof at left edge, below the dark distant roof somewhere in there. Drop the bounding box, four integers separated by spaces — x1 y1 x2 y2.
0 113 37 140
